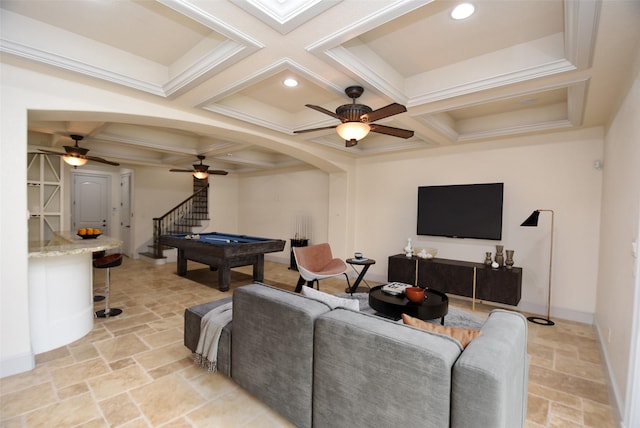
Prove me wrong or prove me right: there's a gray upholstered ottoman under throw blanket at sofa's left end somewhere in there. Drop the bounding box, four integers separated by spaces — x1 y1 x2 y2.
184 297 232 376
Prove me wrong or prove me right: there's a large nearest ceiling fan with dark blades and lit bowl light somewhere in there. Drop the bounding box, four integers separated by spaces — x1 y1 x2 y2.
293 86 413 147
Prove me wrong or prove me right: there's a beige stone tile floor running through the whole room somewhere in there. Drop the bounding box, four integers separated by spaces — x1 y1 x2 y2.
0 259 615 428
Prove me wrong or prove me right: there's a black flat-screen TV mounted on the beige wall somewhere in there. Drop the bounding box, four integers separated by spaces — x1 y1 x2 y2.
417 183 504 240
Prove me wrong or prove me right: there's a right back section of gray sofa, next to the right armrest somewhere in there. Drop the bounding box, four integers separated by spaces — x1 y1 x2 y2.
312 309 462 428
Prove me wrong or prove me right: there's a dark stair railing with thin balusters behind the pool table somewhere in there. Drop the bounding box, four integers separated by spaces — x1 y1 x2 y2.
152 185 209 258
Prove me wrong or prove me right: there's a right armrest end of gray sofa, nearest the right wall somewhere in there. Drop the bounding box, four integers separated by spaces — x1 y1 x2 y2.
451 309 528 428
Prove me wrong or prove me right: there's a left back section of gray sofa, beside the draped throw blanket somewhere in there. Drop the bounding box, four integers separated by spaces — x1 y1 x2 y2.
231 284 330 427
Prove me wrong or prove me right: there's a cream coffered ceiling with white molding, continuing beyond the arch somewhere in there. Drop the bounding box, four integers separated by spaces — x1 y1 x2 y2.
0 0 640 173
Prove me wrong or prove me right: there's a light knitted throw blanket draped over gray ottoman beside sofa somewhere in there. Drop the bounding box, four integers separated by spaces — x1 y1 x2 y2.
194 302 232 372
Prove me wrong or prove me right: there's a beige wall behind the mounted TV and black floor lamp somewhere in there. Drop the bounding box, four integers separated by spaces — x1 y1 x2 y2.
355 129 602 322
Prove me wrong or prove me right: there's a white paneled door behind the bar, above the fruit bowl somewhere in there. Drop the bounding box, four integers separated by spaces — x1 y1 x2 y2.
71 173 111 235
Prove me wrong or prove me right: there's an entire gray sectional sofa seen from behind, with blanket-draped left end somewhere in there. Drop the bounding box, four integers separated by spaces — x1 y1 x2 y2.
185 283 528 428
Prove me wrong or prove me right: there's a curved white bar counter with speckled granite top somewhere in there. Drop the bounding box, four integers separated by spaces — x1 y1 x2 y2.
29 232 122 354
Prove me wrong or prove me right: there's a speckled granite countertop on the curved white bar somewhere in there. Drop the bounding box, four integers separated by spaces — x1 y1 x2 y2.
29 231 122 257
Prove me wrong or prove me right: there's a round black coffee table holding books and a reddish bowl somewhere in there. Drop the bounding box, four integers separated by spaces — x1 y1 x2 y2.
369 285 449 325
